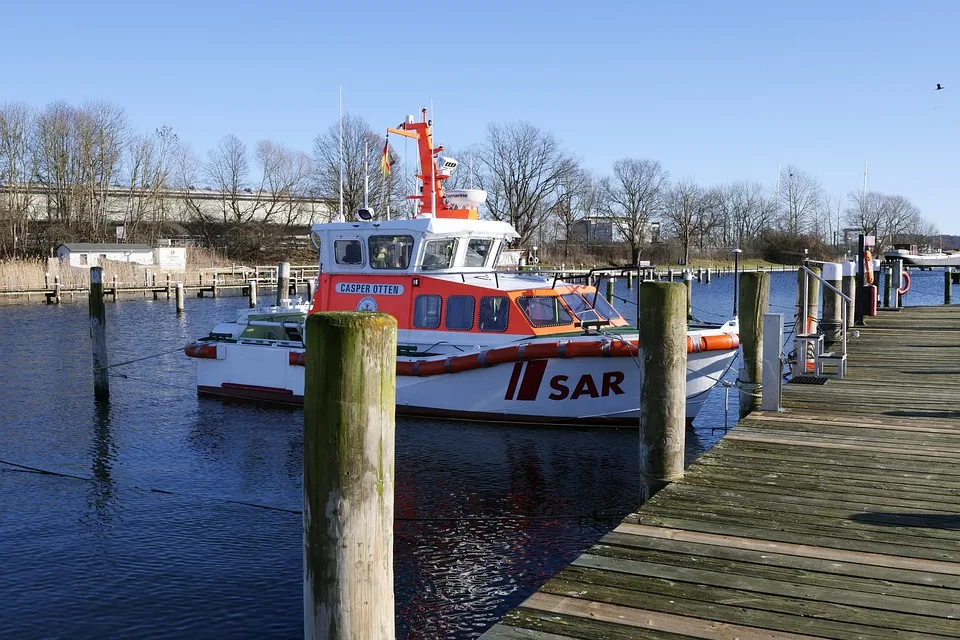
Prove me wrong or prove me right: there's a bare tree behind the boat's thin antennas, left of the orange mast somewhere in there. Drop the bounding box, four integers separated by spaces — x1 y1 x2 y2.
313 114 404 218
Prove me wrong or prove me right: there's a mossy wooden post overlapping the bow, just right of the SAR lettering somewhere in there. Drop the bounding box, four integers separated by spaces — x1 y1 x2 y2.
637 282 687 504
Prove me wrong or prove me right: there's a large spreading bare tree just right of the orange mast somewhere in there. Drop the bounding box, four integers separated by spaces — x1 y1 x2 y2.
480 122 578 246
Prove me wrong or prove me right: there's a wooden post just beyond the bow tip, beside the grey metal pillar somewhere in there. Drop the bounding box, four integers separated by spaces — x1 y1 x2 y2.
737 271 770 418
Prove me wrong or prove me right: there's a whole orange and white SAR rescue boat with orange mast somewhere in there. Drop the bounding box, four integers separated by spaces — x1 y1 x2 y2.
186 111 739 426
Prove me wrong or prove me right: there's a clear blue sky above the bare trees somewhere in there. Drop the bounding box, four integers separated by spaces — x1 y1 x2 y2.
0 0 960 233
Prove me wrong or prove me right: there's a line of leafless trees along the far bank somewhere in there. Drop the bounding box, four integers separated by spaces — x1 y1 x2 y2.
0 101 937 262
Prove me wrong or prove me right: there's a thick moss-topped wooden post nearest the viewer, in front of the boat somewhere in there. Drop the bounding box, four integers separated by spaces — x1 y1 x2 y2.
303 312 398 640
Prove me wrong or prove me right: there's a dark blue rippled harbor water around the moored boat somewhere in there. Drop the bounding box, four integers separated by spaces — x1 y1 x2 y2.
0 271 943 639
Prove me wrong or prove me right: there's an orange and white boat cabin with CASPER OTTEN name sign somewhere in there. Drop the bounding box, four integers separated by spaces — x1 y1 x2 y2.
311 216 627 342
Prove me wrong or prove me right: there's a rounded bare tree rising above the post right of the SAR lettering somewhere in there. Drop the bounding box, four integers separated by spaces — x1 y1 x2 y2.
600 158 669 264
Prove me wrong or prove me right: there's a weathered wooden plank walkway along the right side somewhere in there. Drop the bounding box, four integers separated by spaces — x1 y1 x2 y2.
483 307 960 640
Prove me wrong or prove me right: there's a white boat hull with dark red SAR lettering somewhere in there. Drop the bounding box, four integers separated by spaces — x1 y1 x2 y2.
191 343 737 426
